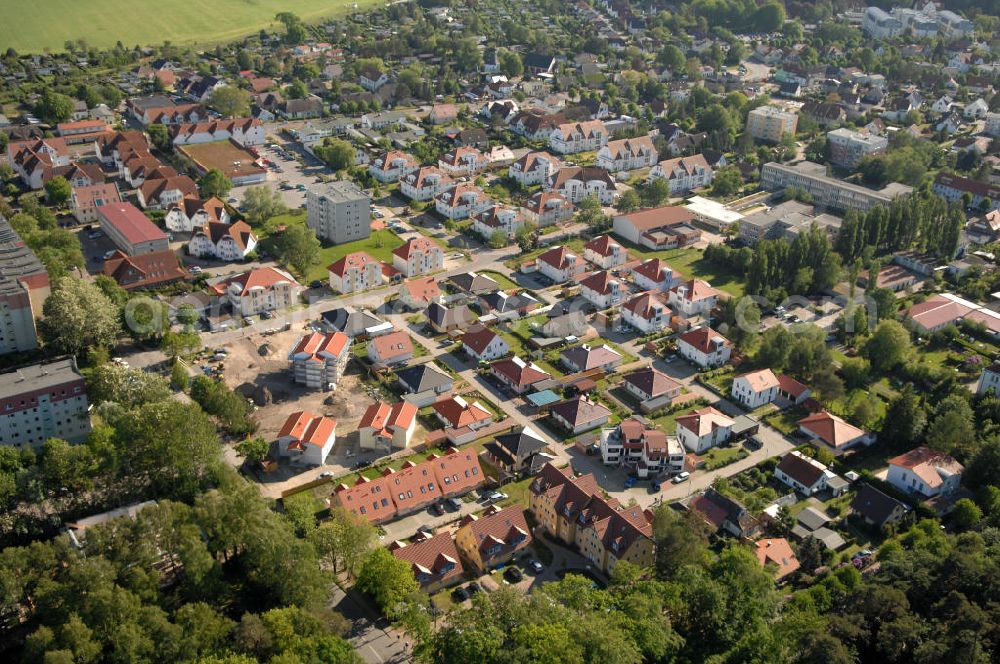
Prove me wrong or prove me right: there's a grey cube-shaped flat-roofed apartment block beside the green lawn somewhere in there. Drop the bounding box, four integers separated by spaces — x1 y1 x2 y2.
306 180 371 244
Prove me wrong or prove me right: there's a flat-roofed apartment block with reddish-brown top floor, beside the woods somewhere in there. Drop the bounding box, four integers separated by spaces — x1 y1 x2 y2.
0 357 90 448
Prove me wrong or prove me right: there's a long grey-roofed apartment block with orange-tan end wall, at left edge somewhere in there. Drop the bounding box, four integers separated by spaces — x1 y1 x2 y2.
0 215 50 354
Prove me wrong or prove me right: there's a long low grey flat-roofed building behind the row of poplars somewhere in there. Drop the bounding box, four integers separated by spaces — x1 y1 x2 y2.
760 161 913 212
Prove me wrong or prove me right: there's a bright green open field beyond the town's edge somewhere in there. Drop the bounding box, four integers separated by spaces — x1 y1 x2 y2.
0 0 382 53
